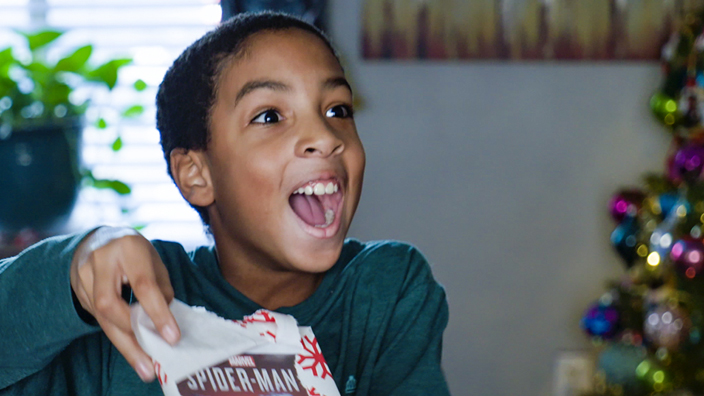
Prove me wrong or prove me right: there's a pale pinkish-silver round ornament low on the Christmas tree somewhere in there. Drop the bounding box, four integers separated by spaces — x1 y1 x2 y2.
643 304 690 351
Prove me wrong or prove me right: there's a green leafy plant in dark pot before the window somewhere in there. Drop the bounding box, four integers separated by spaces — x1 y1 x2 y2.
0 30 146 232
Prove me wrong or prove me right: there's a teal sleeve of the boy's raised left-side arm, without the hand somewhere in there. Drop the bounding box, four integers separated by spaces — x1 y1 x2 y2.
0 233 99 389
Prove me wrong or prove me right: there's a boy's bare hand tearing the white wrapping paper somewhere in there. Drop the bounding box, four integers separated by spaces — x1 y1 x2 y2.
71 227 180 382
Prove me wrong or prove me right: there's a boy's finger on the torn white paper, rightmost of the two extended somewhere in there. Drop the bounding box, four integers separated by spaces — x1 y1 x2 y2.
126 266 180 345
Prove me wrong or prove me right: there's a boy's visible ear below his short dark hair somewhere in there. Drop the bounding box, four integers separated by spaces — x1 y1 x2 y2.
169 148 215 207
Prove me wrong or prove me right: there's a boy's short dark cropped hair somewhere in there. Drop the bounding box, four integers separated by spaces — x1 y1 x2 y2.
156 11 340 225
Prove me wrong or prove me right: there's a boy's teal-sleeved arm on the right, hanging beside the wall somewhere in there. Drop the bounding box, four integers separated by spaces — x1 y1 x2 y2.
369 246 450 396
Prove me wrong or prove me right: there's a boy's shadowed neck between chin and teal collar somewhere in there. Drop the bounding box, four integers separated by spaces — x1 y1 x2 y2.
216 240 324 311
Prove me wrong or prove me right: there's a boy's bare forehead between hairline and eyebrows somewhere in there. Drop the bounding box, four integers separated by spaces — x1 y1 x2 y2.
219 28 344 85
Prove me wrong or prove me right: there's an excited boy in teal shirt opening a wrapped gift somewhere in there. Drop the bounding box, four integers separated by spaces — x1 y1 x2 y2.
0 13 448 395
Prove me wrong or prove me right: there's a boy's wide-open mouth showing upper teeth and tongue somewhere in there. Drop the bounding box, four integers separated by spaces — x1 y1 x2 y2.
288 179 342 228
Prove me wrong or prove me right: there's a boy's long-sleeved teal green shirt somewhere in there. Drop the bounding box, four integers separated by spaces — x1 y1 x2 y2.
0 234 449 396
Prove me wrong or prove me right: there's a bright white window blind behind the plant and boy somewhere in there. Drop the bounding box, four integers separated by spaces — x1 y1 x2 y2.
0 0 221 247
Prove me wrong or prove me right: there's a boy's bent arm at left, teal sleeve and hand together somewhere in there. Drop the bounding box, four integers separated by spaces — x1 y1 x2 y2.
0 227 179 394
